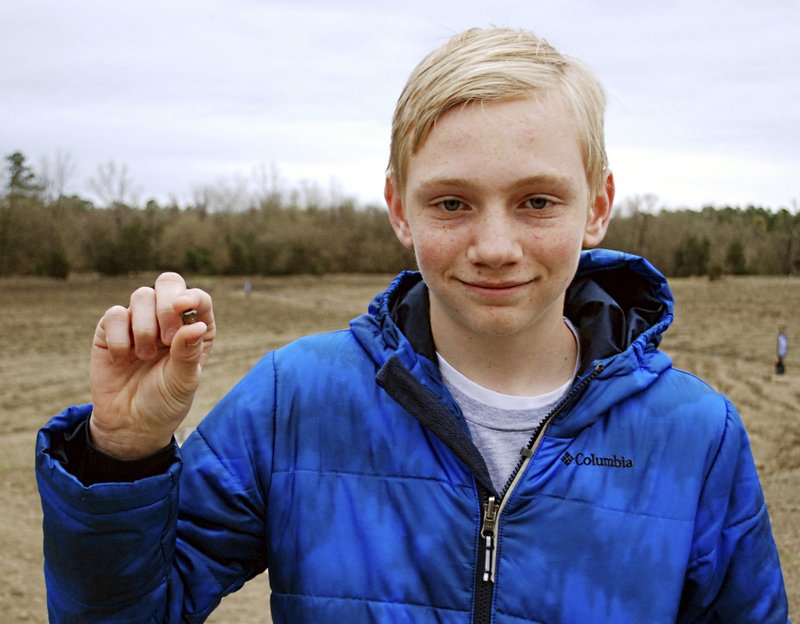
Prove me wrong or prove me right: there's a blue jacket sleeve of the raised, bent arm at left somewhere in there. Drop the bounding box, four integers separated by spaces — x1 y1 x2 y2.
36 356 274 623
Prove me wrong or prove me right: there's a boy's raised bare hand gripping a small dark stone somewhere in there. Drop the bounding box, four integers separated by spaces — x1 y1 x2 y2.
89 273 216 460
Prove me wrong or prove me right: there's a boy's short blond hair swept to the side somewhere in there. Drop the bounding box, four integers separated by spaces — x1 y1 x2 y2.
387 28 608 191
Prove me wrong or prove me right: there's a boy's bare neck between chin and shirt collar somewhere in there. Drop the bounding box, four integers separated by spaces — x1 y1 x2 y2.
431 306 578 396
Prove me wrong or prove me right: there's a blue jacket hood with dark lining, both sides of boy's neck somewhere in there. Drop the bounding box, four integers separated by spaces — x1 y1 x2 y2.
351 249 674 435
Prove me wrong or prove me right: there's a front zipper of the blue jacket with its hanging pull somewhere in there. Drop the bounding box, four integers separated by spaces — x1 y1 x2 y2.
472 364 604 624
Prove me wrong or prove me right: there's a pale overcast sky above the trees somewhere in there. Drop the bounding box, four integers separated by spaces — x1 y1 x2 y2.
0 0 800 208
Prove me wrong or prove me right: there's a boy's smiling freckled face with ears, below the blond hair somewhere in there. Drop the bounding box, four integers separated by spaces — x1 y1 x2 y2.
386 95 613 340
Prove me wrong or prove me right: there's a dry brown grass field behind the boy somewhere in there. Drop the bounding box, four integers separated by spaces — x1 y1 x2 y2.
0 275 800 623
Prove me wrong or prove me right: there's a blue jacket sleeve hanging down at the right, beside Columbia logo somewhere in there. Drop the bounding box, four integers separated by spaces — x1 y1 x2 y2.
679 400 789 624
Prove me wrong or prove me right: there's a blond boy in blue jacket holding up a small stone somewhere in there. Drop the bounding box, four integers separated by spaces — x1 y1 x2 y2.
38 29 787 623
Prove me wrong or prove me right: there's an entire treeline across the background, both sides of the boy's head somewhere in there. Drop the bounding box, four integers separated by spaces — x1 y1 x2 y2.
0 152 800 278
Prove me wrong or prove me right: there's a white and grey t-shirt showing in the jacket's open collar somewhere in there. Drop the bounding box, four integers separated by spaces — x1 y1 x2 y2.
436 318 580 492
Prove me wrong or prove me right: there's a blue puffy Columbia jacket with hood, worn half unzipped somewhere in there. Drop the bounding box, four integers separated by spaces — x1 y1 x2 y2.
37 251 788 624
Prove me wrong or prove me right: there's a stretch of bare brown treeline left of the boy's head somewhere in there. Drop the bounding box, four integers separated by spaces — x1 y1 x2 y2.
0 152 414 278
